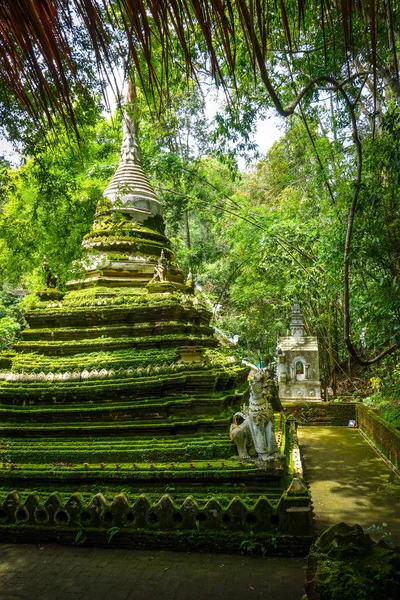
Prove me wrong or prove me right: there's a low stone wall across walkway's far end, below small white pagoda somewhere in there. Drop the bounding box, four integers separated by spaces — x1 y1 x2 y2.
283 402 357 426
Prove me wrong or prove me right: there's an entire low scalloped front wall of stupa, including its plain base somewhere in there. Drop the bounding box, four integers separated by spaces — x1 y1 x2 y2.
0 490 312 556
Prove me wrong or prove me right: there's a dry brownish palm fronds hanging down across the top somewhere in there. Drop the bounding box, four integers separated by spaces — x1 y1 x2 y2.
0 0 398 124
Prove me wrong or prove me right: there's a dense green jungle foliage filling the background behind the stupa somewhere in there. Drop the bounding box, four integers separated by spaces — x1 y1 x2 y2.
0 1 400 422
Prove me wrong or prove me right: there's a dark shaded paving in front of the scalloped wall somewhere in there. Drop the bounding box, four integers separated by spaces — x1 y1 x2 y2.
0 544 304 600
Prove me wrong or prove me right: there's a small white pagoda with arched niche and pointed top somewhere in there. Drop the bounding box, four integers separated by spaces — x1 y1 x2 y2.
277 298 321 402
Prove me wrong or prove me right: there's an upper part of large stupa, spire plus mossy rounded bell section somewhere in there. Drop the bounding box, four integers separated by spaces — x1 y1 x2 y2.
67 89 187 291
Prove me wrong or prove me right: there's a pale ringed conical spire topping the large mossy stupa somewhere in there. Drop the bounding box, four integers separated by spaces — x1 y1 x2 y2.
103 82 161 221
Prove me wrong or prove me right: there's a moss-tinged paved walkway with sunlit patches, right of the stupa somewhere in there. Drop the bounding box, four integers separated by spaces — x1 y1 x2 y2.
298 427 400 545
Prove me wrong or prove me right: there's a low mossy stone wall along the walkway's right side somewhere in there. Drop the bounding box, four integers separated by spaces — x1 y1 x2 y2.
357 404 400 468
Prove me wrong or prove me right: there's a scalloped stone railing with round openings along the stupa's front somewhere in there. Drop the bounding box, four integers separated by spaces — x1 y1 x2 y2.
0 485 311 536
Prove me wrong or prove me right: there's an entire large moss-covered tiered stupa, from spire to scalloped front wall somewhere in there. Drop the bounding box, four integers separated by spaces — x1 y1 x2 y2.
0 94 310 553
